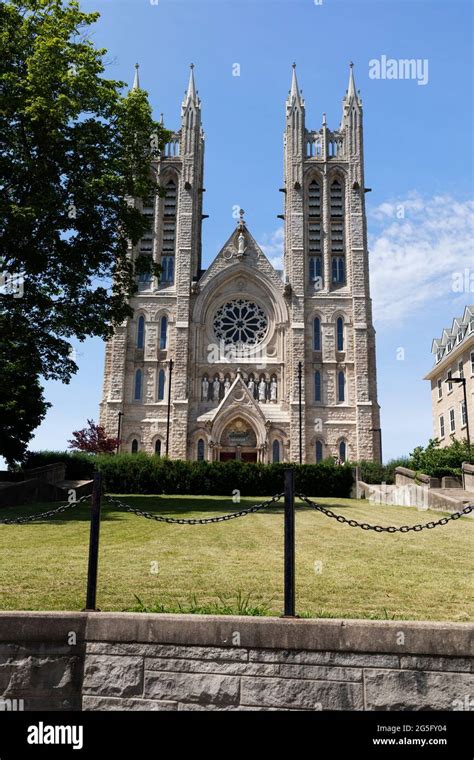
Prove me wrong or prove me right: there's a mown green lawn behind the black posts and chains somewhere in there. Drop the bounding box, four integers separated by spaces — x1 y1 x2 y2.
0 495 474 621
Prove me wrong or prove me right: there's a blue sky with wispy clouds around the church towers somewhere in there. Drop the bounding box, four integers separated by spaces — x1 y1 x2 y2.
30 0 474 460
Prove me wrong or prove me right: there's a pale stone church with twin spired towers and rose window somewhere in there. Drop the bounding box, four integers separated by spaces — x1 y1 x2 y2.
100 65 380 463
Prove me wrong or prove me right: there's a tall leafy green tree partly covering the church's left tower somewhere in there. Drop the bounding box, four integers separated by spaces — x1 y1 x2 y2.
0 0 169 464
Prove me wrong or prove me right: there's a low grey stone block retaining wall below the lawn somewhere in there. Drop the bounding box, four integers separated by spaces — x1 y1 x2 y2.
0 612 474 710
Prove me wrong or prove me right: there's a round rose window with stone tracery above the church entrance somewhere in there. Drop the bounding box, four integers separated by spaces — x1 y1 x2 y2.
214 298 268 346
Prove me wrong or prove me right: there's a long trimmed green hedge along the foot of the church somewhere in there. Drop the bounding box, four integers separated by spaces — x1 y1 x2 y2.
23 452 353 498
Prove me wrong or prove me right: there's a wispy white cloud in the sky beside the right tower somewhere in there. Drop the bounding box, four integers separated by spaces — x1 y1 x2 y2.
369 193 474 323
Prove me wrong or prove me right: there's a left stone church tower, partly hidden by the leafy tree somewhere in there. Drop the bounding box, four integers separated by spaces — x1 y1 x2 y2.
100 64 204 459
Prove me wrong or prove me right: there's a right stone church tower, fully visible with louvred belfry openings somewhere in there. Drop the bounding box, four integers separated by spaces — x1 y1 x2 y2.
282 64 380 462
